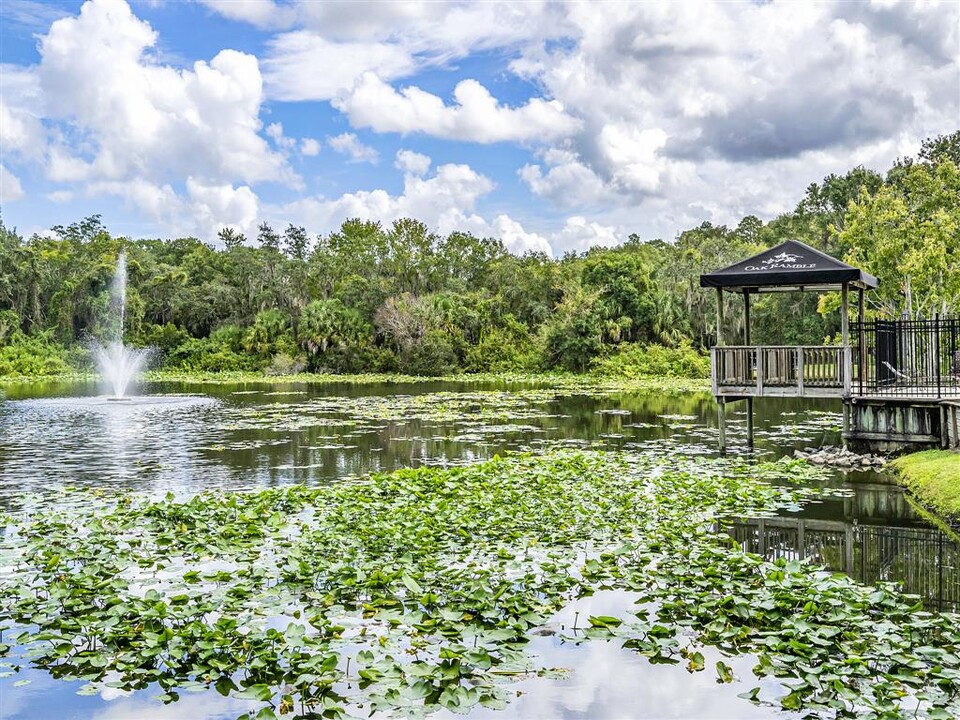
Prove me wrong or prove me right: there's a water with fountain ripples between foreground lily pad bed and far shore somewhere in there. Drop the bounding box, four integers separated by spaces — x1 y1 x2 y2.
0 376 839 502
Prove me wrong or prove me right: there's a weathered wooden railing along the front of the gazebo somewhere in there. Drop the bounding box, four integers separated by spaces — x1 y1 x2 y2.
710 345 851 397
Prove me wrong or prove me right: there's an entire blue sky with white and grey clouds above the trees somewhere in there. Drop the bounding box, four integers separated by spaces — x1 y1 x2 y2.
0 0 960 253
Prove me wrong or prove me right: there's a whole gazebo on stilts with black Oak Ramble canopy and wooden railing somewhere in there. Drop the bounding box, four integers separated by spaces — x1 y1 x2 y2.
700 240 879 448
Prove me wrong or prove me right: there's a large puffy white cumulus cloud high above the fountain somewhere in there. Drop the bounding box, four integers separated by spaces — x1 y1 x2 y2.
36 0 295 184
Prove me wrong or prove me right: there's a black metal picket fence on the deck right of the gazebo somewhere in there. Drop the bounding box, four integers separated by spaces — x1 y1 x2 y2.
851 316 960 398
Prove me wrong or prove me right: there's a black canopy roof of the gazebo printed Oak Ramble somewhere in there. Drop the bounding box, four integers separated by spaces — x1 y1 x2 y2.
700 240 878 292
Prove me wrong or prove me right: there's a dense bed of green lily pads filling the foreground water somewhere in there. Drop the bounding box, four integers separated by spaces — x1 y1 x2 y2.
0 450 960 718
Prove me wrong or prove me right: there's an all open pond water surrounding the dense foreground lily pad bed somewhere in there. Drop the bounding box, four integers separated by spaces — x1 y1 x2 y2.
0 382 960 720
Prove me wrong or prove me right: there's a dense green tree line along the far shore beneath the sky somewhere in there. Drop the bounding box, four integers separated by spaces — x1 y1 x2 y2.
0 133 960 375
